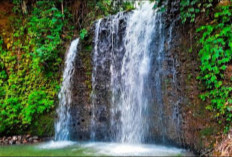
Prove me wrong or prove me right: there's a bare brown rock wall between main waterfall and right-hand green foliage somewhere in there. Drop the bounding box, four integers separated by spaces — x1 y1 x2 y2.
173 14 223 155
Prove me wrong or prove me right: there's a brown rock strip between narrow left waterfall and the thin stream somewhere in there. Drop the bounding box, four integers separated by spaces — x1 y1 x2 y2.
69 40 91 140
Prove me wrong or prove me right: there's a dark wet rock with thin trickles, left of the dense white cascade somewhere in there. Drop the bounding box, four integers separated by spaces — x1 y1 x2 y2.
91 13 126 140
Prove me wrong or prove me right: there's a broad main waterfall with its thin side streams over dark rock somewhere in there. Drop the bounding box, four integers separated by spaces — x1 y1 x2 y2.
91 2 180 143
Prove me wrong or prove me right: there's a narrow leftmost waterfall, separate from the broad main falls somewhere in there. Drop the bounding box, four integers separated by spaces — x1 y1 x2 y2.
55 38 79 141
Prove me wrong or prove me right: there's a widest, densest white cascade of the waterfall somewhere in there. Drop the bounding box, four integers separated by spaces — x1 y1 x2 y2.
115 3 159 143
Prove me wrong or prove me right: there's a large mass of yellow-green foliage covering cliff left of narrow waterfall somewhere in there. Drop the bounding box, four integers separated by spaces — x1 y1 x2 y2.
0 0 72 134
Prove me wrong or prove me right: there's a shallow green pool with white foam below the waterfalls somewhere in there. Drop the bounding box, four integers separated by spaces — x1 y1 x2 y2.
0 141 190 156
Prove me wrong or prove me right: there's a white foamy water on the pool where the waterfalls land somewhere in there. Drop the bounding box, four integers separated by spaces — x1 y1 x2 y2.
36 141 187 156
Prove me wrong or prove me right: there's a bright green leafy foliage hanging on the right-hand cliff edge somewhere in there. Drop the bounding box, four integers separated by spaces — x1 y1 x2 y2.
197 6 232 129
